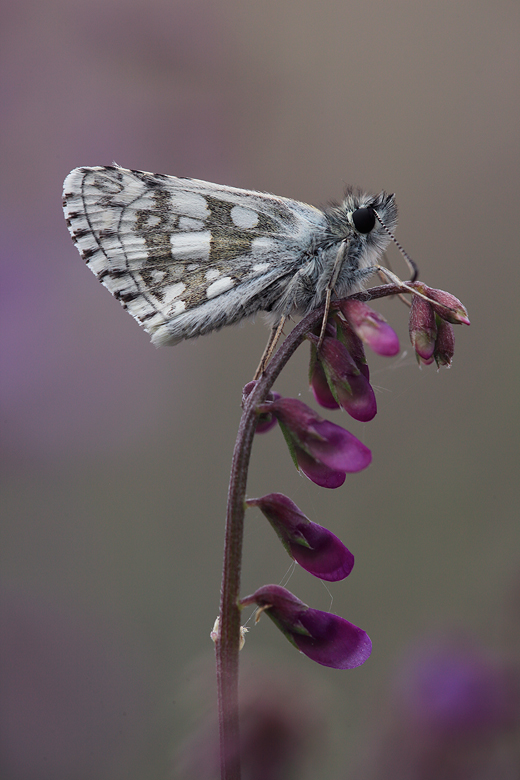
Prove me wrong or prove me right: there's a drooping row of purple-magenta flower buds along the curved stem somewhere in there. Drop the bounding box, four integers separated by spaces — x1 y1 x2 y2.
240 282 469 669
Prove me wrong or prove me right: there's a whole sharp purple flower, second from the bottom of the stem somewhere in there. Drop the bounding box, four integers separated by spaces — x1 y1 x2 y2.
246 493 354 582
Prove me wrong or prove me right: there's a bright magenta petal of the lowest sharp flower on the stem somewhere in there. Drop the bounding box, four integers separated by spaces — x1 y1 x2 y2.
292 609 372 669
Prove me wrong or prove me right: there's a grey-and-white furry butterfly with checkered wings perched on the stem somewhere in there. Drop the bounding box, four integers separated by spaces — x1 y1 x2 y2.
63 166 397 362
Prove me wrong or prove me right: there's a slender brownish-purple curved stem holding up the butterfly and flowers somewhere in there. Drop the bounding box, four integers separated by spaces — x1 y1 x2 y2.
215 284 408 780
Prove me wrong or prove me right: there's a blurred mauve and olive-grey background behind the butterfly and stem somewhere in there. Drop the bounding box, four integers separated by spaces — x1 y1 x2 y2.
0 0 520 780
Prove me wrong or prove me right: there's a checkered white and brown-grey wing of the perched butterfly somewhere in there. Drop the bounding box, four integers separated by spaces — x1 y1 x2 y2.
63 167 325 345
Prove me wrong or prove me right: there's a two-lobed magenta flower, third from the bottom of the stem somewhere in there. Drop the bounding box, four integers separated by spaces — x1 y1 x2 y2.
260 398 372 488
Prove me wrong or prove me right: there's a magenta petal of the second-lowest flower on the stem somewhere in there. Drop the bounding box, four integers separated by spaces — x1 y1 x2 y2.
289 523 354 582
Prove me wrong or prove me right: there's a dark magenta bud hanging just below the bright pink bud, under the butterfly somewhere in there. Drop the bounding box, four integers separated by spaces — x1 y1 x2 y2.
308 335 377 422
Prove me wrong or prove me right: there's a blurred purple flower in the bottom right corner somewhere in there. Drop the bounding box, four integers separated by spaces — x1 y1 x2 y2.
358 632 520 780
